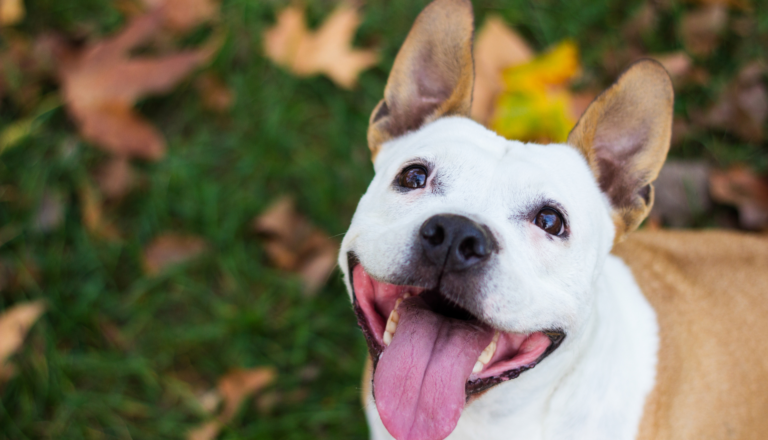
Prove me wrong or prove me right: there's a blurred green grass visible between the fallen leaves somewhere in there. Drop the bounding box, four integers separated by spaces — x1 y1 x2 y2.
0 0 768 440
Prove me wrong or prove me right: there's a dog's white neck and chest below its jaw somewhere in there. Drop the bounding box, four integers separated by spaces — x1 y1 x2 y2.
368 256 658 440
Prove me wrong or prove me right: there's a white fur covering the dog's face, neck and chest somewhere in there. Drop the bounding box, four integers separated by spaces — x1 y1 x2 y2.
339 117 658 440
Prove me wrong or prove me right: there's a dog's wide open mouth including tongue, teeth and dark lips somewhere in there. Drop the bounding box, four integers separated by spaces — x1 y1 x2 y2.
348 253 565 440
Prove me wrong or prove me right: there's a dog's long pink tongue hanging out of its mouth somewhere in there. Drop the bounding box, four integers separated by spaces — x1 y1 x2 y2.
373 297 493 440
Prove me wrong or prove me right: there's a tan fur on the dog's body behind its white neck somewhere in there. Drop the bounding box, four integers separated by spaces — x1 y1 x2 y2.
613 231 768 440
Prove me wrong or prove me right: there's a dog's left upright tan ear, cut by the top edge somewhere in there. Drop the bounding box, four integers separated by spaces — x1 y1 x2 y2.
368 0 474 159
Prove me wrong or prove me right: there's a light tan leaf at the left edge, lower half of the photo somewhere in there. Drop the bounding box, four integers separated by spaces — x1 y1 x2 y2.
0 301 45 382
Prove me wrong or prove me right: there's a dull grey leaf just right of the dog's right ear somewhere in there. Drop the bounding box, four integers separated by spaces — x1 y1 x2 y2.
650 160 712 228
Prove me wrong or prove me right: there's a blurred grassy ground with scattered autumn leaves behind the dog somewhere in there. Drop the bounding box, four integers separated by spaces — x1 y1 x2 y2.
0 0 768 440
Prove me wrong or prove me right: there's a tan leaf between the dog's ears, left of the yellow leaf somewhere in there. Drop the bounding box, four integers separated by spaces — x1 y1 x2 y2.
471 15 533 125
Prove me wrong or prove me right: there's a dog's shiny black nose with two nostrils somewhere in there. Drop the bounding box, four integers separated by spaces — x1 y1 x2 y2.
419 214 496 271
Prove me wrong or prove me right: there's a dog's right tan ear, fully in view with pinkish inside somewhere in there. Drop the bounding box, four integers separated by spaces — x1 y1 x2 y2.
568 60 674 241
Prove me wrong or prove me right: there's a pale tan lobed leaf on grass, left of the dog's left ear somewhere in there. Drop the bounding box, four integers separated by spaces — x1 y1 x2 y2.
264 4 379 89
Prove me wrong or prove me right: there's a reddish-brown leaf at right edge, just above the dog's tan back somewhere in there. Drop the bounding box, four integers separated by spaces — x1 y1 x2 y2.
709 166 768 230
